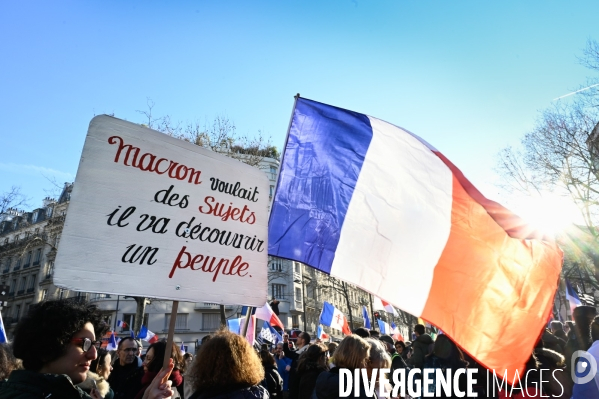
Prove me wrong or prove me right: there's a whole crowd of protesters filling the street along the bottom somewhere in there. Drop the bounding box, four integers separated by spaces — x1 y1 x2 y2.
0 300 599 399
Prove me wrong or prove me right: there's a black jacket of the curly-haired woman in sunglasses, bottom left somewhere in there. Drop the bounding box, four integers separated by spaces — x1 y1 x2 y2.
0 370 91 399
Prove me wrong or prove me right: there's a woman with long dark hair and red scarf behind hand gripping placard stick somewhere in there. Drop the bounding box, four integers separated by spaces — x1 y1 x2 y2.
135 340 183 399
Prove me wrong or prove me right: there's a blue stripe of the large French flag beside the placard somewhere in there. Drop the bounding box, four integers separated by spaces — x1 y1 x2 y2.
268 98 372 273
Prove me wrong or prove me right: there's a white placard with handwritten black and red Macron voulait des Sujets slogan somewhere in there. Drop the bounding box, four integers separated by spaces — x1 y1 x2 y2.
54 115 269 306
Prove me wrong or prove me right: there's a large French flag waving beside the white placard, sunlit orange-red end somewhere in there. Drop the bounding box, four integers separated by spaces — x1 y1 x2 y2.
269 98 562 381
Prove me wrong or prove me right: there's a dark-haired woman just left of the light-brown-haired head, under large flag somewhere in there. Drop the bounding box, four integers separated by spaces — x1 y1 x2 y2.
289 344 328 399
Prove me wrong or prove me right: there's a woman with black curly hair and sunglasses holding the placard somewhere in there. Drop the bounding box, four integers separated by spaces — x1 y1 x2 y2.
0 300 172 399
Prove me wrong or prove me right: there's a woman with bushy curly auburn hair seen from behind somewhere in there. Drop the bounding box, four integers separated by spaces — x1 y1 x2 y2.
188 331 268 399
